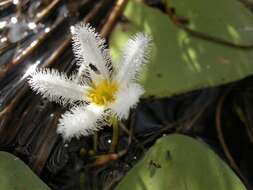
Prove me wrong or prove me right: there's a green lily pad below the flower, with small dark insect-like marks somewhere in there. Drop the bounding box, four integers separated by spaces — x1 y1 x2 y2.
116 134 246 190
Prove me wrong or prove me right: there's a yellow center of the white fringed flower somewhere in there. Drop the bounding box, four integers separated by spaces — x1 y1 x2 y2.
87 80 119 105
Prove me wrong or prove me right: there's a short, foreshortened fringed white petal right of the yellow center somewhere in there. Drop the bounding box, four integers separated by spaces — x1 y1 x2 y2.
110 83 144 119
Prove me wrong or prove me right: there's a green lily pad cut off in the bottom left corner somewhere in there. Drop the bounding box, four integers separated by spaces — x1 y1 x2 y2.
0 151 50 190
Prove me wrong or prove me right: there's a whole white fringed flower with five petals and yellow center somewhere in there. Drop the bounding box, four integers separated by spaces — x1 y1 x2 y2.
29 24 151 140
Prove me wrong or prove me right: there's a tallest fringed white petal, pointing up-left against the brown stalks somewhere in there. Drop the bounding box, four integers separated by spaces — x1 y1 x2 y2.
71 23 111 79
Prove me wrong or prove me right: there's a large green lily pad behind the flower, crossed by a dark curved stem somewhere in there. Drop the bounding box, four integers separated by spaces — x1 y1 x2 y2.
110 0 253 97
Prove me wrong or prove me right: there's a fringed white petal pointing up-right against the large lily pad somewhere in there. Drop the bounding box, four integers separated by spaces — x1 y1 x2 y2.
115 33 151 83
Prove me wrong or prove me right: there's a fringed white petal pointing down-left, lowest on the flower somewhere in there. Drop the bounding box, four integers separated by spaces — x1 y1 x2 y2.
57 104 106 140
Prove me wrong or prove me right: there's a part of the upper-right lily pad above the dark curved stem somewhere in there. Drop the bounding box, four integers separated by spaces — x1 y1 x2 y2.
164 0 253 45
